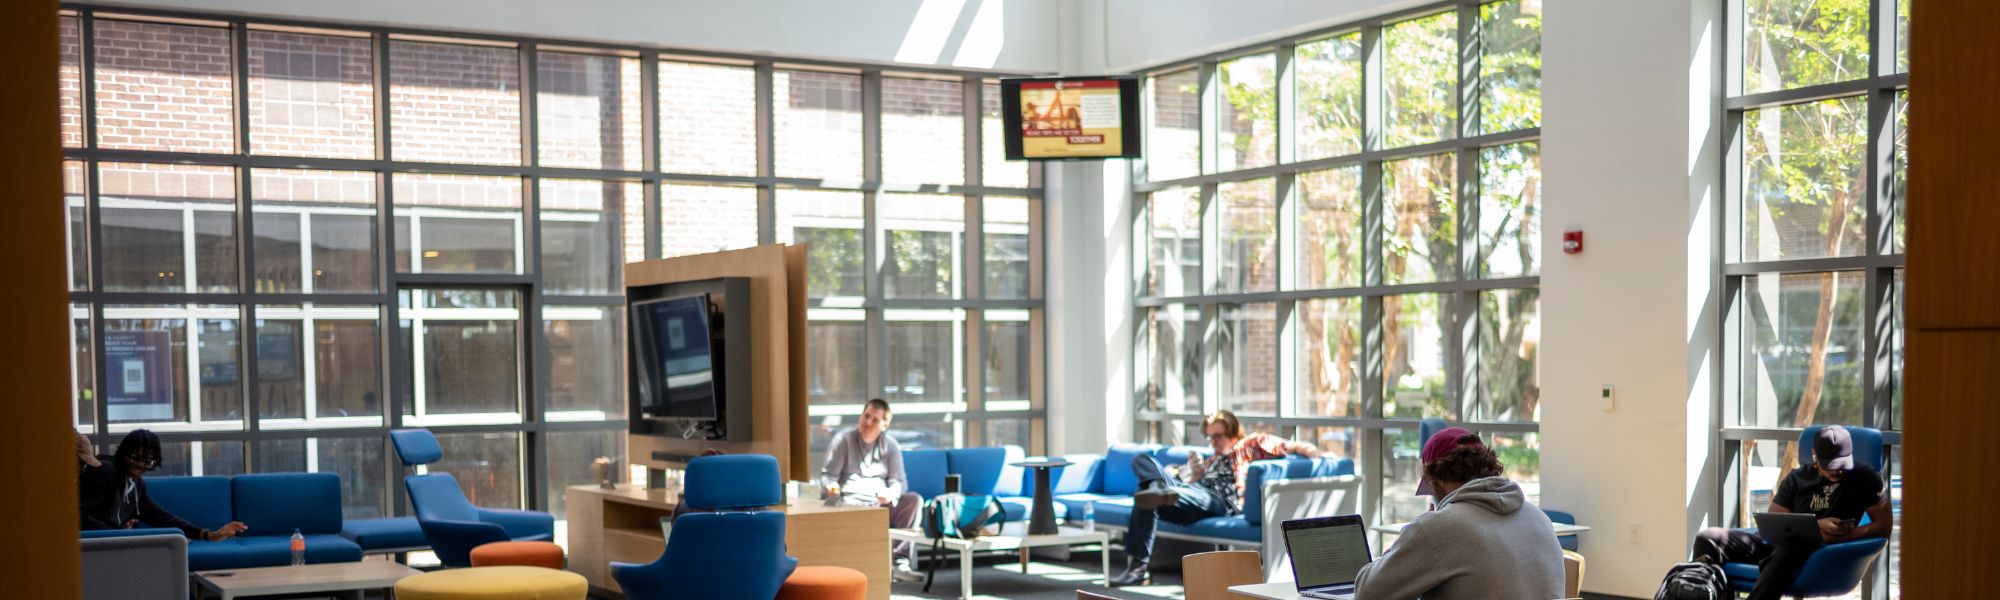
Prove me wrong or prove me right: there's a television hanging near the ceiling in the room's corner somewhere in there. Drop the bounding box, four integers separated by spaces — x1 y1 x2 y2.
1000 78 1138 160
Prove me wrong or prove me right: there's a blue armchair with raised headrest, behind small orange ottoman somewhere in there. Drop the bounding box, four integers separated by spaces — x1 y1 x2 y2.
388 430 556 566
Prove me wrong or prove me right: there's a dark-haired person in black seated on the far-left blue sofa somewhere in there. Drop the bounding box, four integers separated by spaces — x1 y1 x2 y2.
76 430 246 542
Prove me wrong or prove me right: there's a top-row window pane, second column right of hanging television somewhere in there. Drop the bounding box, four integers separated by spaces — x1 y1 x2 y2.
1216 54 1278 172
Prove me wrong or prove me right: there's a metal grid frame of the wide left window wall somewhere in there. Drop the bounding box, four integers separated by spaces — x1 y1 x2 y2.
62 2 1048 514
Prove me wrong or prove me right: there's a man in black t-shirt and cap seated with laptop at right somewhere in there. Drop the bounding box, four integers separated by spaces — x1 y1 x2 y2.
1694 426 1896 600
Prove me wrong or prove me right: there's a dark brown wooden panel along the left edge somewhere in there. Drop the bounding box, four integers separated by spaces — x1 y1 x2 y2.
0 0 82 600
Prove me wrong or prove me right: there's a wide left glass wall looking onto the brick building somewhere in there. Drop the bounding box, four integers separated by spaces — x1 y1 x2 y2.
62 6 1042 518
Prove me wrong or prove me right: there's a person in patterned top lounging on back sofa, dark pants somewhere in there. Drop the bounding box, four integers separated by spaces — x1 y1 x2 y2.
1112 410 1320 586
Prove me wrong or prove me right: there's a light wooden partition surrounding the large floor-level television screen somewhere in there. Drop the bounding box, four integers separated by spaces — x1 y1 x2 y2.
626 244 808 480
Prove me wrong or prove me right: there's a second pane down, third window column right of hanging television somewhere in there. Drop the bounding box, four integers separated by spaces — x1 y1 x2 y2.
1294 166 1362 290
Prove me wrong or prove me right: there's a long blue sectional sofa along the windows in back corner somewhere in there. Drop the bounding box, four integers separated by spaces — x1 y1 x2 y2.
902 444 1360 574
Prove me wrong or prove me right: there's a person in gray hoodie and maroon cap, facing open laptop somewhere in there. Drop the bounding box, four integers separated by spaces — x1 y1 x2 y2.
1354 428 1564 600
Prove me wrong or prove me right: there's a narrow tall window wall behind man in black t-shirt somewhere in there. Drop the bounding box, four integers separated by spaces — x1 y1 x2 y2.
1716 0 1910 598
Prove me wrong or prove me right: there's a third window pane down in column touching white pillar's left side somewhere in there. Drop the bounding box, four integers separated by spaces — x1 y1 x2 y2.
1472 290 1542 422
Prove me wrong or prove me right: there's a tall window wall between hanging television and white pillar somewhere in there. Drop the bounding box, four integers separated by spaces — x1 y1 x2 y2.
1132 0 1536 536
